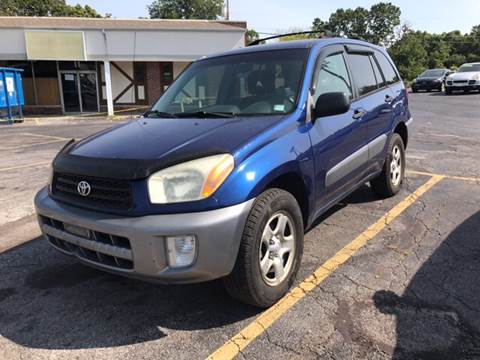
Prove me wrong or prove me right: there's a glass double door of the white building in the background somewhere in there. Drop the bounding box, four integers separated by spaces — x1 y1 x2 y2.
61 71 99 113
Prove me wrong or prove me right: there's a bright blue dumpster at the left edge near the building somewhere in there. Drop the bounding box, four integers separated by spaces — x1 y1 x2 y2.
0 67 25 122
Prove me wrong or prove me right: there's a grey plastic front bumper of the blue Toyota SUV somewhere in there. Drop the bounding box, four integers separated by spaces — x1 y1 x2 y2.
35 188 254 283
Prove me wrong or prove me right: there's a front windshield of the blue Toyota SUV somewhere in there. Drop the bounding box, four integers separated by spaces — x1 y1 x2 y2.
150 49 308 117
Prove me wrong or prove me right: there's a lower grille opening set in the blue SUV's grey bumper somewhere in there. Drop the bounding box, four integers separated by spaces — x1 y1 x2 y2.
41 216 133 270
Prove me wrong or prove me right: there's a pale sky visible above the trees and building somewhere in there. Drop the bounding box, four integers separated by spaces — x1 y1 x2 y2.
67 0 480 33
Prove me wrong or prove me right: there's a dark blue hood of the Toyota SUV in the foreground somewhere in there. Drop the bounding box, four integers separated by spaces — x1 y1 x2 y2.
54 115 281 179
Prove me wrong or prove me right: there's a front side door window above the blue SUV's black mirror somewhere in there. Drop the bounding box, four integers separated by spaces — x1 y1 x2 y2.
313 53 353 103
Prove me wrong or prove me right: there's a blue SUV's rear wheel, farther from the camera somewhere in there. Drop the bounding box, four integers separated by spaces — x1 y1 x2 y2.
370 133 405 197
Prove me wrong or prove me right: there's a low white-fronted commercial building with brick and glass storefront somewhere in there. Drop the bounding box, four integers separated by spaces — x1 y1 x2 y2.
0 17 246 114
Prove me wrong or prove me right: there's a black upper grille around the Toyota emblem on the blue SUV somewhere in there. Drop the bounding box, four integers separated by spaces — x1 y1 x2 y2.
52 172 132 210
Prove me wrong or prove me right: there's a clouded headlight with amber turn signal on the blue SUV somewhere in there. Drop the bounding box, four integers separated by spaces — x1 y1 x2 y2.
148 154 234 204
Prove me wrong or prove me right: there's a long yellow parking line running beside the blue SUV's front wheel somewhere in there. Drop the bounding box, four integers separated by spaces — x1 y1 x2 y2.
207 175 444 360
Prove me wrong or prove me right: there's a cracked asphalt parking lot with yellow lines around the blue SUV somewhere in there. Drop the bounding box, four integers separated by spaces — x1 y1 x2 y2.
0 93 480 360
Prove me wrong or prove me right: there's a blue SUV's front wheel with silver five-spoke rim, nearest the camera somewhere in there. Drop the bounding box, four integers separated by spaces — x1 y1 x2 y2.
223 189 304 308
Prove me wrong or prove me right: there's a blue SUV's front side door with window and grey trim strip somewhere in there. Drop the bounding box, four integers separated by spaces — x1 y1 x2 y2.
310 46 368 211
